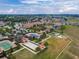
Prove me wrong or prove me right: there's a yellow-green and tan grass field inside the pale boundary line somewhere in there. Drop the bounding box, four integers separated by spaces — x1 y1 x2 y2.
14 36 70 59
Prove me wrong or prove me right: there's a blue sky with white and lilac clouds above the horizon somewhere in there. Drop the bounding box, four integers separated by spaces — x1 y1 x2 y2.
0 0 79 14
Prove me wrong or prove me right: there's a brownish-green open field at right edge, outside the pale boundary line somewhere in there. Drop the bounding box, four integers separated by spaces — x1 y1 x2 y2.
59 26 79 59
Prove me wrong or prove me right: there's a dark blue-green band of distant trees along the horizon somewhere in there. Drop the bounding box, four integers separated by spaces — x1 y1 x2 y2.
0 14 79 22
